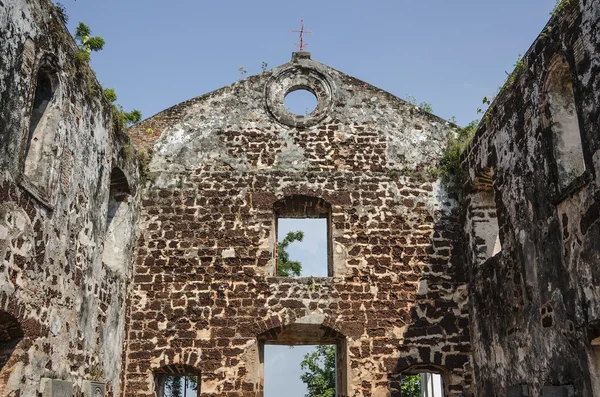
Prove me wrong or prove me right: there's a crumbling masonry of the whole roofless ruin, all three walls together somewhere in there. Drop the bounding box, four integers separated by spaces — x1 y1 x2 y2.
0 0 600 397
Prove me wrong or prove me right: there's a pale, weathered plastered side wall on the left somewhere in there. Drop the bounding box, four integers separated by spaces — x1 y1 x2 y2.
0 0 137 396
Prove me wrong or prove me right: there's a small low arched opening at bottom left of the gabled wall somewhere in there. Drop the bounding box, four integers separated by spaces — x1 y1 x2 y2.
154 365 202 397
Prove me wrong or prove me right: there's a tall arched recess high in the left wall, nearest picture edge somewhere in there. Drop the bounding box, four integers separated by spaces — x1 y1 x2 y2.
21 55 60 199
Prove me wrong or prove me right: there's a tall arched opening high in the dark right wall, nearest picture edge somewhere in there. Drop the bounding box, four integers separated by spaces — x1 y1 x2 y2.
544 55 585 190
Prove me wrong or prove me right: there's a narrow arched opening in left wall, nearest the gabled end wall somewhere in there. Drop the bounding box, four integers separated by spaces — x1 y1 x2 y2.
102 167 133 271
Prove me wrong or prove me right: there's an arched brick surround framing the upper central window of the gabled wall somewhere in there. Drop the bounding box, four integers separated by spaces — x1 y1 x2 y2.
273 194 334 277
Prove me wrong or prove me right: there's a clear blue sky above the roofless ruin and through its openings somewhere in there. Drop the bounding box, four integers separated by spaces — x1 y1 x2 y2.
56 0 555 397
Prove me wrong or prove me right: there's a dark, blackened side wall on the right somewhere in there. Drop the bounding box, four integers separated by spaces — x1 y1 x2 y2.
463 1 600 397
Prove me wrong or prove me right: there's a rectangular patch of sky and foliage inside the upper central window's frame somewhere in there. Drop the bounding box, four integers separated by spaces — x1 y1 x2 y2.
276 217 333 277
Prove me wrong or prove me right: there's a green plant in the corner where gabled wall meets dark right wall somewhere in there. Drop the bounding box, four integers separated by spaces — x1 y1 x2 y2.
440 121 478 193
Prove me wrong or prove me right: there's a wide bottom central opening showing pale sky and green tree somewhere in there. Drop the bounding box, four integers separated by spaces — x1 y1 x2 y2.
263 344 340 397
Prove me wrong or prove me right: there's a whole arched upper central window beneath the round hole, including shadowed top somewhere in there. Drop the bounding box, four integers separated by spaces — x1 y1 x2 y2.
274 195 333 277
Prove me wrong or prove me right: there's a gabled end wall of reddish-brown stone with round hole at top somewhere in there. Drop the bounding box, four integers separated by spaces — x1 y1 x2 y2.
124 53 472 396
